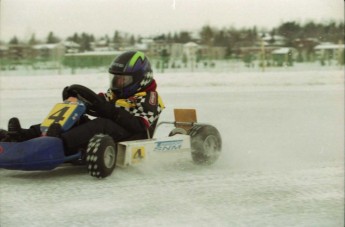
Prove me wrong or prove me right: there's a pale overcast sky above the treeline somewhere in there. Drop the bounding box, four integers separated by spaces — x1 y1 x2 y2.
0 0 344 41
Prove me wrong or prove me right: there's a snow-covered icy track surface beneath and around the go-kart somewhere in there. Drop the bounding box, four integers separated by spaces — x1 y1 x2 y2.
0 69 344 227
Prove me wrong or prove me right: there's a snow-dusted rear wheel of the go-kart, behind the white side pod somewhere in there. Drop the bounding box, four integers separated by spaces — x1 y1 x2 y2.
188 125 222 165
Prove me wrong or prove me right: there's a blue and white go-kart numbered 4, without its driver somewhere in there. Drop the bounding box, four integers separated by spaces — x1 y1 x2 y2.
0 84 222 178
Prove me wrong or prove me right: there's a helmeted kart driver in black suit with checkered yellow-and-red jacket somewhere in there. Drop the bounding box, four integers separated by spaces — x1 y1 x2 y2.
0 51 164 156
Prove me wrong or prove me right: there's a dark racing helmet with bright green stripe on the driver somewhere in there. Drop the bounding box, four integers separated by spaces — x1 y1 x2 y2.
109 51 153 98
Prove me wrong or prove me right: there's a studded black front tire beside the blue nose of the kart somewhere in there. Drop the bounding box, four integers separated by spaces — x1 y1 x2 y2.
86 134 117 178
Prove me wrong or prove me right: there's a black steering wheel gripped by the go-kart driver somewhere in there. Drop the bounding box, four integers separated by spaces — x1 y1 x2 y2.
62 84 103 116
